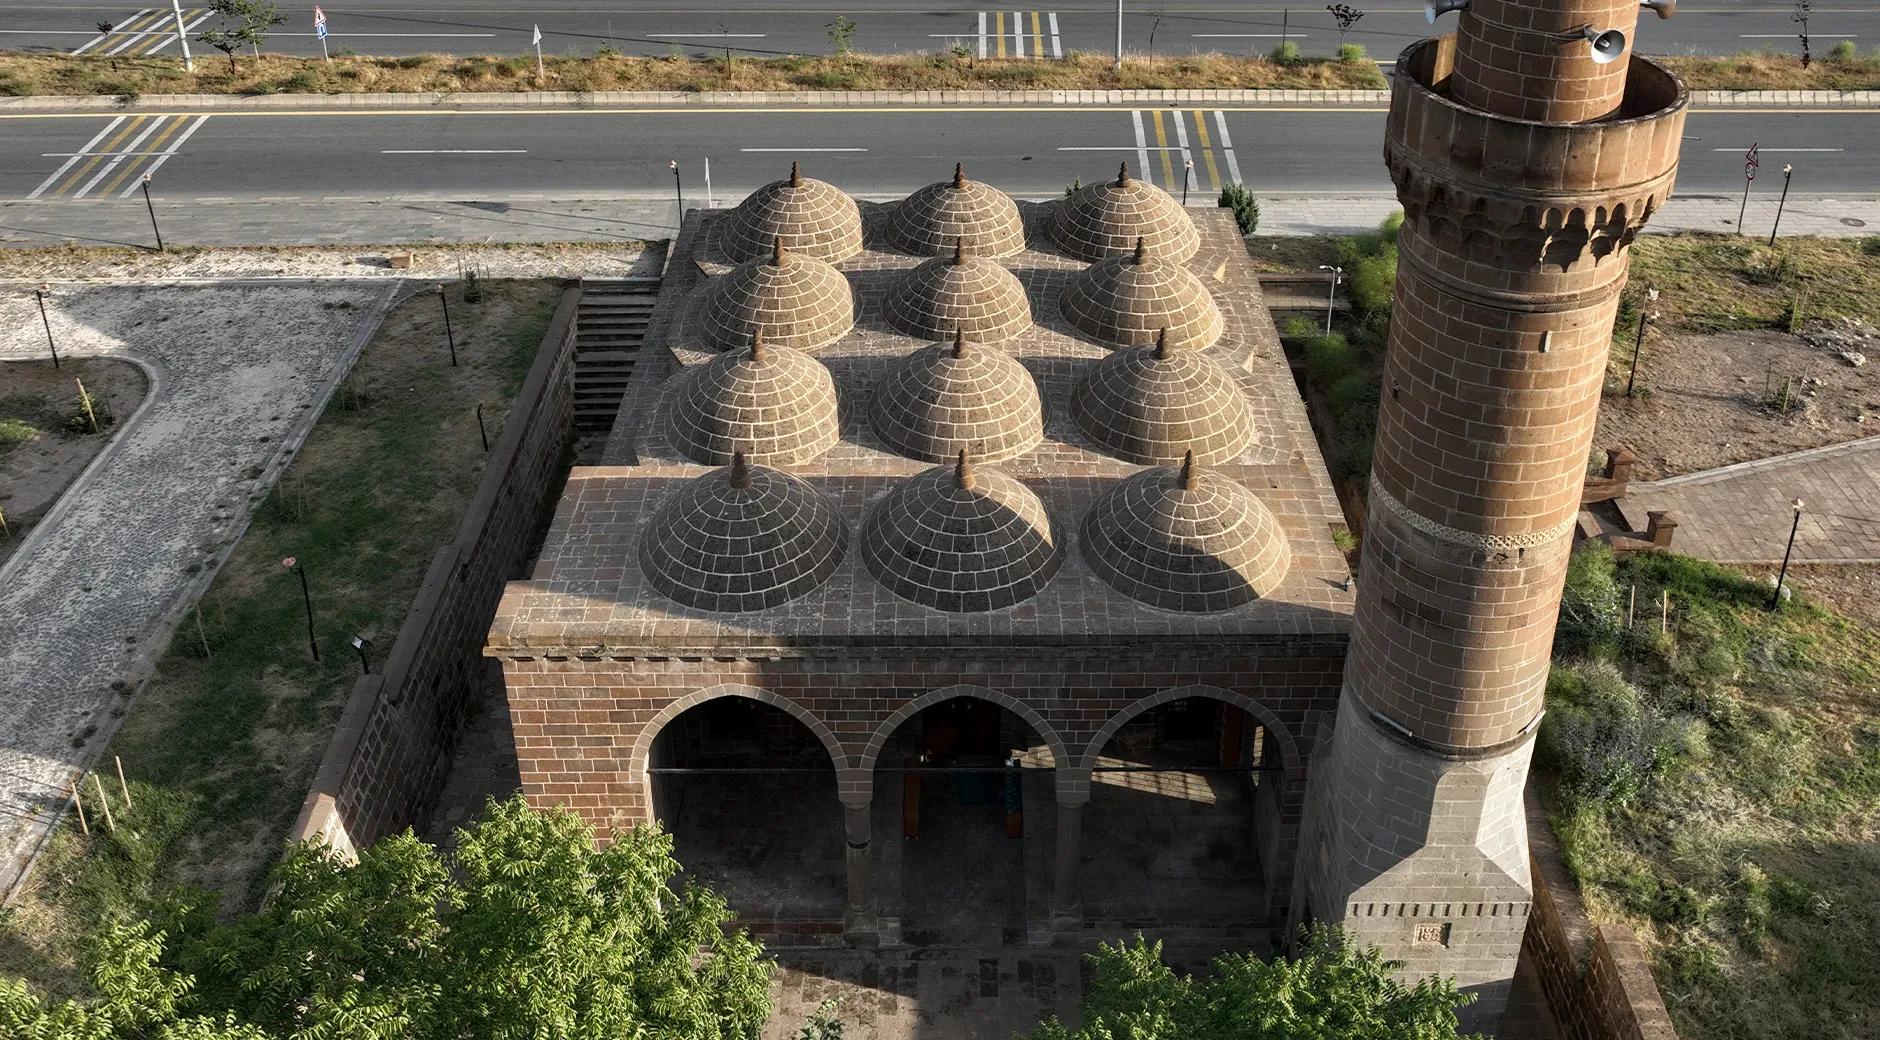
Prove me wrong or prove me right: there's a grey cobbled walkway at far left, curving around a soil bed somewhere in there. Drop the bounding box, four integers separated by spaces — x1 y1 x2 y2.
0 282 397 891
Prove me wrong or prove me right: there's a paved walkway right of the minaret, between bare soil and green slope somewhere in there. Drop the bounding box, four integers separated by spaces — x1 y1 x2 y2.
1619 436 1880 564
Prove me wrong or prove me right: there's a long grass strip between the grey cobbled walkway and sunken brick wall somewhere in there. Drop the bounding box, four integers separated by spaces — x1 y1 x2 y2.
0 280 560 993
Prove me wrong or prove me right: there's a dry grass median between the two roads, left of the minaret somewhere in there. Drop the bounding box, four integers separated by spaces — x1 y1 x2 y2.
0 55 1384 96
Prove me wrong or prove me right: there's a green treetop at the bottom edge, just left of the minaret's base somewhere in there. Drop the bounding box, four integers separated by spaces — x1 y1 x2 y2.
1030 929 1474 1040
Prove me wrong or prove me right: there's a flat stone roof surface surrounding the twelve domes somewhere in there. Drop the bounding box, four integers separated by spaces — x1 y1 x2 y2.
487 203 1355 656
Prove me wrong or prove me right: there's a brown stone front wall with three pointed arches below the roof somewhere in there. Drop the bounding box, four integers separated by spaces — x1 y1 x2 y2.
504 645 1342 918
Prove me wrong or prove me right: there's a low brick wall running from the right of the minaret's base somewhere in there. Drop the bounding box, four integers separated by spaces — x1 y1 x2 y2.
1521 794 1677 1040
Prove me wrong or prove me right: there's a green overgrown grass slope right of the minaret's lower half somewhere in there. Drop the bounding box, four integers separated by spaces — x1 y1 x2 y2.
1538 547 1880 1040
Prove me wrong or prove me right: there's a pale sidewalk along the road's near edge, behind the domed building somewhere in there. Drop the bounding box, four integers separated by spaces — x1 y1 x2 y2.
0 194 1880 248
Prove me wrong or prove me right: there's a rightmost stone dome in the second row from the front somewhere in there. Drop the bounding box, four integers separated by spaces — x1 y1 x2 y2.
1070 330 1254 466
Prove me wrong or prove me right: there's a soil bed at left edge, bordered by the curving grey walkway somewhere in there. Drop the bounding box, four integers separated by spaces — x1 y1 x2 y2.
0 357 149 564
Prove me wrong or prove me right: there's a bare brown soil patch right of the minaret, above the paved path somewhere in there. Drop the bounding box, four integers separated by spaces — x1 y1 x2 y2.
1594 329 1880 480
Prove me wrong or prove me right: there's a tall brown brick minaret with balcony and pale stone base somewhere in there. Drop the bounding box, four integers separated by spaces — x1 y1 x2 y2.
1301 0 1684 1029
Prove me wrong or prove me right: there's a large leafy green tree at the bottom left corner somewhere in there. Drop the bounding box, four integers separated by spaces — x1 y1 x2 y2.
0 797 771 1040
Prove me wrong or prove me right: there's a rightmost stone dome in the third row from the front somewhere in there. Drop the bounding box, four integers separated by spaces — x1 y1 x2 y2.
1058 239 1220 350
